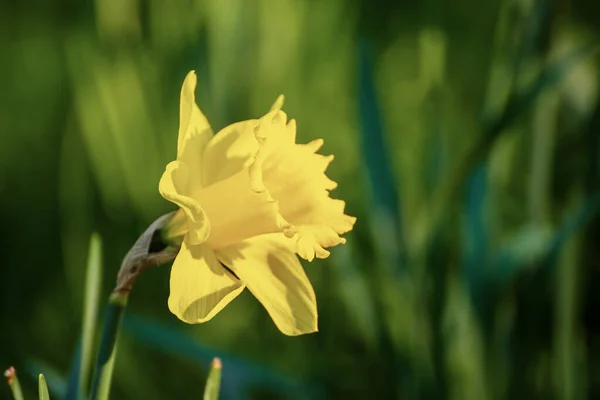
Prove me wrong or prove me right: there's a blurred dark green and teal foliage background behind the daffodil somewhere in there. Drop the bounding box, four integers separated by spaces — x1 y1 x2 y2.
0 0 600 399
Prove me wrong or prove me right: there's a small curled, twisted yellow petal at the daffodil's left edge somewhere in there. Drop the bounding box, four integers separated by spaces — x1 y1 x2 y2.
158 161 210 245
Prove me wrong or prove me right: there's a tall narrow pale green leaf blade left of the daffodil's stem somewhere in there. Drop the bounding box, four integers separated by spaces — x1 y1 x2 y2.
79 233 102 391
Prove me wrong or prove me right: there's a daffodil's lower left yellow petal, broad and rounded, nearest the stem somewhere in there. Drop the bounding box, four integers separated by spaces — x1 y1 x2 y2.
168 241 244 324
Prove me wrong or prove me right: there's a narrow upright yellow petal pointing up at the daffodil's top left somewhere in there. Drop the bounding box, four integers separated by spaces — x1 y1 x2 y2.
177 71 213 180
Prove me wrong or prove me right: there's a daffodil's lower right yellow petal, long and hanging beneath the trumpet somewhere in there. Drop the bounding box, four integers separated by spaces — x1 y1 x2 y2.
217 233 318 336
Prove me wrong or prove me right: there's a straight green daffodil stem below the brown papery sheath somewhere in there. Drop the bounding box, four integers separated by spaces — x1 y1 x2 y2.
89 293 128 400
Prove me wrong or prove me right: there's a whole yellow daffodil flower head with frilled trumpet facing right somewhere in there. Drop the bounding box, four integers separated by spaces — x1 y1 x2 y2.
159 71 356 335
